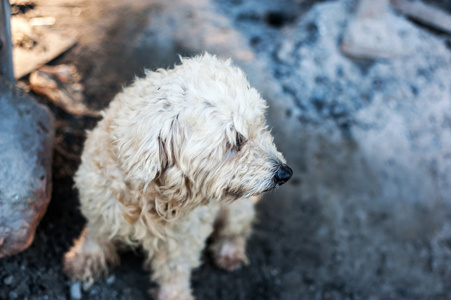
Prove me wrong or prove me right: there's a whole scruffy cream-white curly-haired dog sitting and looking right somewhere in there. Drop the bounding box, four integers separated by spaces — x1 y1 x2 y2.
65 54 292 299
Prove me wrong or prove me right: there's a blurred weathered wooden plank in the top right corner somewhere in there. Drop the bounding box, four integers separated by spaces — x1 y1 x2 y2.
391 0 451 33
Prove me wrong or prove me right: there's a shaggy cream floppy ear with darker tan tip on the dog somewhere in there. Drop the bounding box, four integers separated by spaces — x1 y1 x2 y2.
112 115 196 221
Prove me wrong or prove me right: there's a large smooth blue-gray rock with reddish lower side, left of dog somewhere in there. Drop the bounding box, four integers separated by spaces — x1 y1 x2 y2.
0 76 54 258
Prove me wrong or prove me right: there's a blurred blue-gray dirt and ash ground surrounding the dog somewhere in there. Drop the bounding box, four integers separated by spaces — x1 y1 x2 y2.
0 0 451 299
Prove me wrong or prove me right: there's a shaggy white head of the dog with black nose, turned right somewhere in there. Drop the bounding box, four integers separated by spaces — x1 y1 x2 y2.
112 54 292 217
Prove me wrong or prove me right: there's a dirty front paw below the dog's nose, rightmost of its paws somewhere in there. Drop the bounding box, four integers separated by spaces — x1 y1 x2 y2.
212 238 249 271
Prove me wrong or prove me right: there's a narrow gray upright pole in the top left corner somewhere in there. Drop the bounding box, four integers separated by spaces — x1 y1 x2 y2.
0 0 14 82
